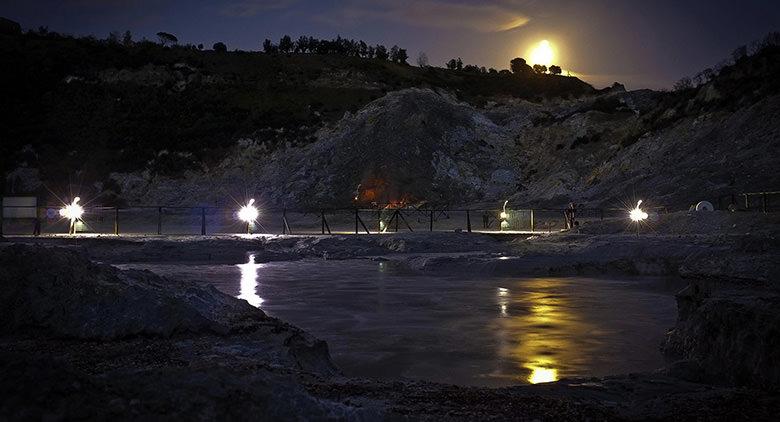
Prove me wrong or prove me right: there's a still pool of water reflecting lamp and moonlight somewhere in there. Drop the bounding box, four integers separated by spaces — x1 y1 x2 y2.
121 260 683 386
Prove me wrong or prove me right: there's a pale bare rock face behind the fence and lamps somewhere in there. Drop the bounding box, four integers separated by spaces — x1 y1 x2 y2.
106 83 780 207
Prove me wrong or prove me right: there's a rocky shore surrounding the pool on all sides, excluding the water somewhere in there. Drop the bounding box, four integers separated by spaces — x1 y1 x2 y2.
0 213 780 420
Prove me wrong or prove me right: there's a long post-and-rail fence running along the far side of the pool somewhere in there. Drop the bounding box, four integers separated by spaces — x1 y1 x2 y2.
0 206 611 236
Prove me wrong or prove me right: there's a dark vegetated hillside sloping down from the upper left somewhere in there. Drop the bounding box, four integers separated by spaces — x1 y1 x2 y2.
0 29 593 198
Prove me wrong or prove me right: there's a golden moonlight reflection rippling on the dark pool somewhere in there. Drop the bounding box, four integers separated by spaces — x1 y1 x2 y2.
498 278 588 384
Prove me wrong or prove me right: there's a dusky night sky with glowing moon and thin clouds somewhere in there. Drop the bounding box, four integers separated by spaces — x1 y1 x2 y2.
0 0 780 89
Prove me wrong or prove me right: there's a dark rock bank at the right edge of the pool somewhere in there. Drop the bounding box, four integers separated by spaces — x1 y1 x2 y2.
663 280 780 391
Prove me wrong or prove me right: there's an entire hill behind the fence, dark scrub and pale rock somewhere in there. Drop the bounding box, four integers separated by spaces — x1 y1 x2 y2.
0 28 780 207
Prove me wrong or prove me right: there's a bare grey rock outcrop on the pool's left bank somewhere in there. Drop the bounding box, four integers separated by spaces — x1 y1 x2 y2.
0 245 337 375
